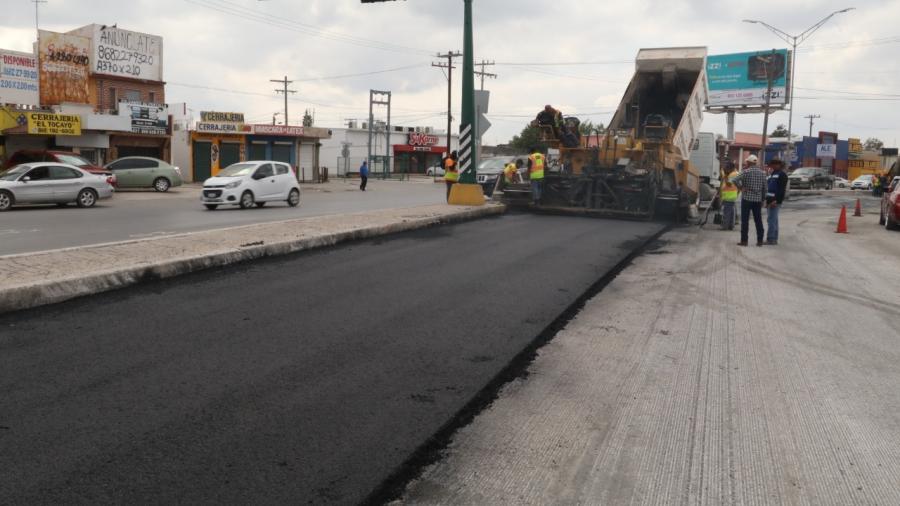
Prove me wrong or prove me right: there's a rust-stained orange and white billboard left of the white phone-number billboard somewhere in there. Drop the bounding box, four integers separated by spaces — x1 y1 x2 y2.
38 30 91 105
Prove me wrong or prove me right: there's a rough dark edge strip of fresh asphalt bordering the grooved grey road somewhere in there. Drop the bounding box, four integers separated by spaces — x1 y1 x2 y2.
360 225 675 506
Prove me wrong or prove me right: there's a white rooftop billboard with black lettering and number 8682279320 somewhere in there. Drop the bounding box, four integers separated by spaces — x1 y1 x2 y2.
91 25 162 81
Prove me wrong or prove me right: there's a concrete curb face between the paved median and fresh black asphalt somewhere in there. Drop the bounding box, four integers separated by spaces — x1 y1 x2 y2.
0 205 506 315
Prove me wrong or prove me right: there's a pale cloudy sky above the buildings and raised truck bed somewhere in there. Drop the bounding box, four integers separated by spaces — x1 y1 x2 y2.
0 0 900 146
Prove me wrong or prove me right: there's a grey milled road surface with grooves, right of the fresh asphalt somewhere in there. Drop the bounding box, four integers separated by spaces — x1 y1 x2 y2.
402 199 900 505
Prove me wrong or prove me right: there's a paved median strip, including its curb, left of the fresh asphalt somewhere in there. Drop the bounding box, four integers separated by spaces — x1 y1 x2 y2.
0 204 505 313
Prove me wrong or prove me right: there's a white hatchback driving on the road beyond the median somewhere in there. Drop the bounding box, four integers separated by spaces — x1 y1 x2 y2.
200 160 300 211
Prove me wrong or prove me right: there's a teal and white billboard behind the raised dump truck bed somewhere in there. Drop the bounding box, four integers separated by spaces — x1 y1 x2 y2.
706 49 790 107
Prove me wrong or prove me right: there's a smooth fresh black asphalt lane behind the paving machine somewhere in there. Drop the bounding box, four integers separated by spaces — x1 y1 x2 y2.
0 214 661 504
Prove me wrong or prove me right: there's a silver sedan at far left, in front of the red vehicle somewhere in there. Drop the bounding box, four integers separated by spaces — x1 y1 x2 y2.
0 162 113 211
